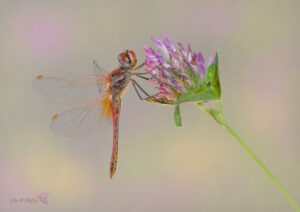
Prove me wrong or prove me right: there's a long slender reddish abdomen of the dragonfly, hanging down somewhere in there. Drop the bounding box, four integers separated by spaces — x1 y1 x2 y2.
110 98 121 178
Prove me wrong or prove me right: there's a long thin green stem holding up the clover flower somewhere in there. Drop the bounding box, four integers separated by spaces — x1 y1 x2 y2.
199 105 300 212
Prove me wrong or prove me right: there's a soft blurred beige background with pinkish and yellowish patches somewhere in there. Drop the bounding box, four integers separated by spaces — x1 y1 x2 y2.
0 0 300 212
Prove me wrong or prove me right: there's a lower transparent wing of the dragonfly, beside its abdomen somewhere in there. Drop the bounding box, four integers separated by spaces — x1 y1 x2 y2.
50 98 107 136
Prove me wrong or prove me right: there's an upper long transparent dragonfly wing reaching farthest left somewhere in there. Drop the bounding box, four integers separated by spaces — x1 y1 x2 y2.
32 75 106 105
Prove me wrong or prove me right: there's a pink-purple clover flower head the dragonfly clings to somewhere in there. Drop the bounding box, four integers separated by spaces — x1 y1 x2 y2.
144 36 218 104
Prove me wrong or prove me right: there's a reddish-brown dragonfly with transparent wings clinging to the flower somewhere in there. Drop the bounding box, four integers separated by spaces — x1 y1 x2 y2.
33 49 153 178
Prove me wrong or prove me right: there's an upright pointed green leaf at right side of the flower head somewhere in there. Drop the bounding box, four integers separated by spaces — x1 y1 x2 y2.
205 53 221 97
